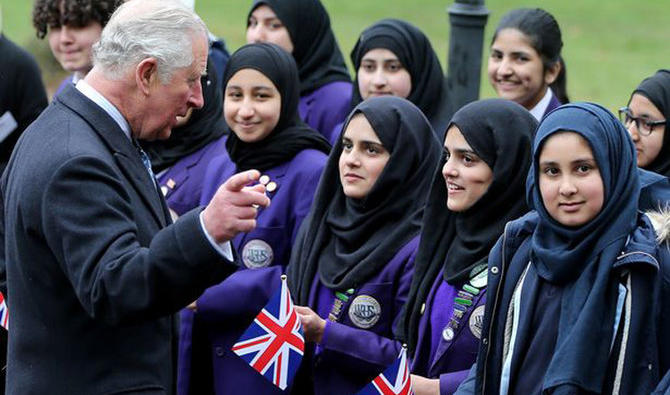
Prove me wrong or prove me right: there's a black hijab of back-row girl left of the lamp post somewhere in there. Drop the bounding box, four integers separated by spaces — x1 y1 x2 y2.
351 19 453 139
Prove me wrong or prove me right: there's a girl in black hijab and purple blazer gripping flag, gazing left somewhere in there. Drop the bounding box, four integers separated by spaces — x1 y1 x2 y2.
287 97 440 394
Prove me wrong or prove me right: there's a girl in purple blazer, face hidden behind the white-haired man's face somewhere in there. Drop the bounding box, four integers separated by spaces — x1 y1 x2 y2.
140 61 226 219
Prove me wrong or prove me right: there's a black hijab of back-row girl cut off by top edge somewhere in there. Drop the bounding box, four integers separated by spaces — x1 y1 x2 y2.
247 0 351 96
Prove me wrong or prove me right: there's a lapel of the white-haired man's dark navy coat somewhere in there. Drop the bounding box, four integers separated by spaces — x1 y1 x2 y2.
56 86 169 228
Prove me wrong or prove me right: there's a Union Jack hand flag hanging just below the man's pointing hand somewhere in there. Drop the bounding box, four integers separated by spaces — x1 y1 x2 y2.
232 276 305 390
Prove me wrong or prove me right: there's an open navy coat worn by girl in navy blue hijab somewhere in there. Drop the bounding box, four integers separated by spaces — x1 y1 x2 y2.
456 218 670 395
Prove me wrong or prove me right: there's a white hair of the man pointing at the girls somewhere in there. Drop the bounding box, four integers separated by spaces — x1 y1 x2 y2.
93 0 207 84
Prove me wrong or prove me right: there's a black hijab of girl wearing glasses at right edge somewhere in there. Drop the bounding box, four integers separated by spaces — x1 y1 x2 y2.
628 70 670 176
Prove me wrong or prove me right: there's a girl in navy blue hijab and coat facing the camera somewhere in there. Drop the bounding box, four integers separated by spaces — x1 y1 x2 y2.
457 103 670 394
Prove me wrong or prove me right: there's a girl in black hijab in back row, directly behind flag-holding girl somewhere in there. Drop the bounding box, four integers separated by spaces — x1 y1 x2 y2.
330 19 453 142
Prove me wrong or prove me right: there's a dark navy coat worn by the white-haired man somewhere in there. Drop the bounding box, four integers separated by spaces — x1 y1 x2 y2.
0 85 235 395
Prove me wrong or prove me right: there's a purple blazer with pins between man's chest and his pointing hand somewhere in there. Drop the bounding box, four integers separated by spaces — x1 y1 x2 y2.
158 136 226 217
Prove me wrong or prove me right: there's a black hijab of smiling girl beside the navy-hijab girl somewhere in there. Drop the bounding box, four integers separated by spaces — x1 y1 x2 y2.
397 99 537 353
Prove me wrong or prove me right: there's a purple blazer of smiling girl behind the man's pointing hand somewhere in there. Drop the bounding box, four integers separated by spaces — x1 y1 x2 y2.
177 143 327 395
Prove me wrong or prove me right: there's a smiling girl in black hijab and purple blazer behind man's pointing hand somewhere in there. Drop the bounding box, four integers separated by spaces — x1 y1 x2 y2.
178 43 330 395
